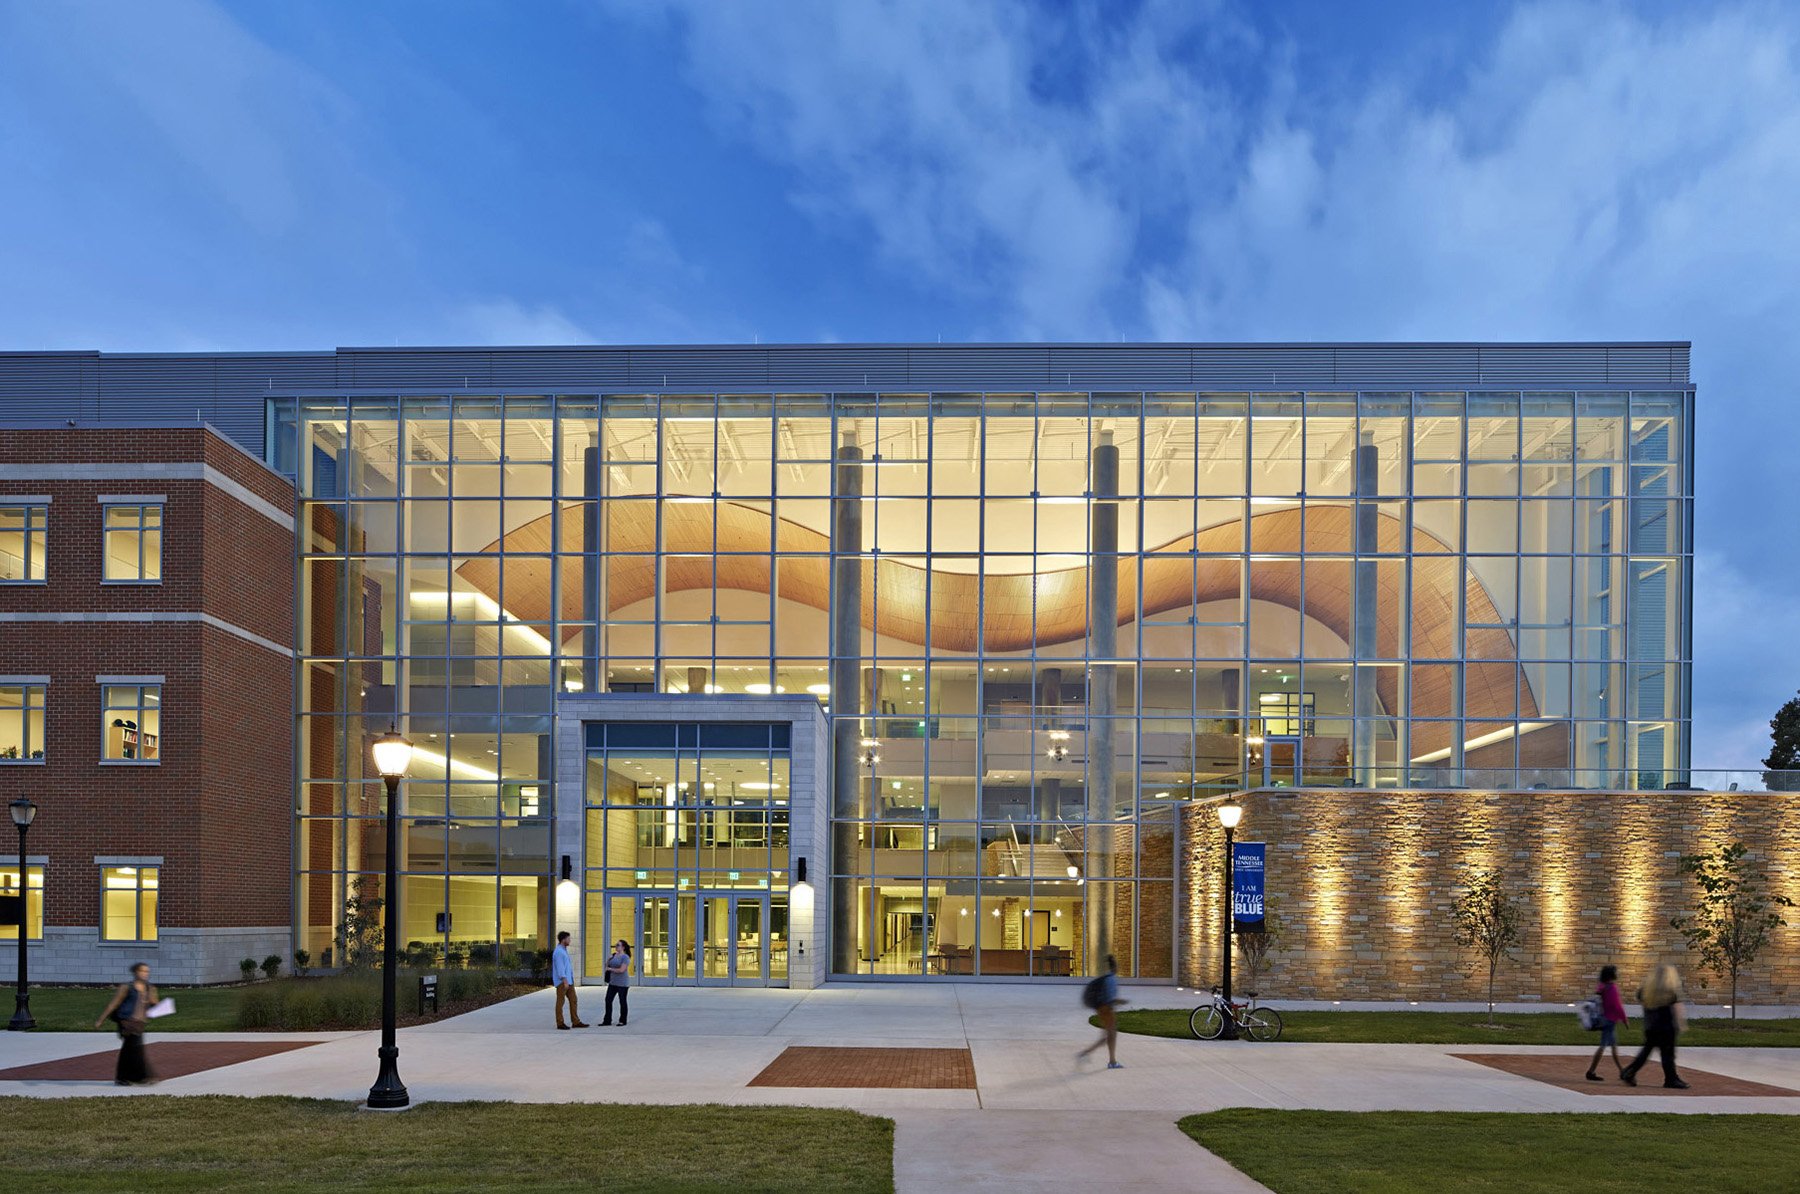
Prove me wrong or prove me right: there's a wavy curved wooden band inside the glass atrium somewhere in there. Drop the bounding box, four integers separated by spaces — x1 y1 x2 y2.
457 502 1537 749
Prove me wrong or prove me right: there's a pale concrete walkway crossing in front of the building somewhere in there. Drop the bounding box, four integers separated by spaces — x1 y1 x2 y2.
0 983 1800 1190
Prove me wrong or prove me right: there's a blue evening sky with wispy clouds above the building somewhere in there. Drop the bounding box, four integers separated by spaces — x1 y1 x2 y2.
0 0 1800 767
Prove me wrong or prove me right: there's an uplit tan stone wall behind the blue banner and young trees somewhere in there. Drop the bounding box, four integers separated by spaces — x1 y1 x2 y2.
1179 789 1800 1005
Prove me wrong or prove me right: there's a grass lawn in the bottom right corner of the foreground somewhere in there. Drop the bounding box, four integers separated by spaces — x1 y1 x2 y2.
1181 1108 1800 1194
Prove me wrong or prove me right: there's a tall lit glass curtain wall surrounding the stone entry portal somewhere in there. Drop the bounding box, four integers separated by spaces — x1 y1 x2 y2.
272 391 1690 978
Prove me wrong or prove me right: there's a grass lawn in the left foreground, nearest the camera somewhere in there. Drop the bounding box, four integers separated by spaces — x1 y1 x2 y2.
0 1094 895 1194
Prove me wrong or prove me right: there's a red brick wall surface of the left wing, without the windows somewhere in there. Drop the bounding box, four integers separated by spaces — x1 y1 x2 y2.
0 429 295 980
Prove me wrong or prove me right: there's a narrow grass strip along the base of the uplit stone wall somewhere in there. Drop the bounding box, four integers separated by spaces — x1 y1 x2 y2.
1091 1005 1800 1048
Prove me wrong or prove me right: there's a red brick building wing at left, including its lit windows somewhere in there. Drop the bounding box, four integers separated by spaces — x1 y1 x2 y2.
0 427 295 981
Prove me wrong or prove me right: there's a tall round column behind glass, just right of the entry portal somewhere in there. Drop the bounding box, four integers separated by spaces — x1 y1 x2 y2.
819 432 864 974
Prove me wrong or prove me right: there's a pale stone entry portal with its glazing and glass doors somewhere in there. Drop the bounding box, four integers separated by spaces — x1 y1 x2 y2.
556 693 830 989
